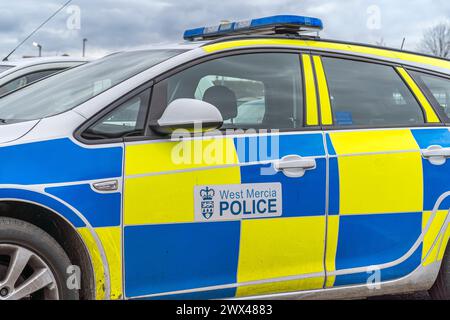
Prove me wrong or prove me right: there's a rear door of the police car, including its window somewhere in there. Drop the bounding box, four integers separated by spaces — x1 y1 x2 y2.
314 56 448 287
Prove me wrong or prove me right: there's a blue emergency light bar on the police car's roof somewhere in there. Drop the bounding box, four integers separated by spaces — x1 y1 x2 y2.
183 15 323 41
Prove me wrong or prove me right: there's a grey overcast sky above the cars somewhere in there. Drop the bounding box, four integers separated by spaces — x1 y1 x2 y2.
0 0 450 58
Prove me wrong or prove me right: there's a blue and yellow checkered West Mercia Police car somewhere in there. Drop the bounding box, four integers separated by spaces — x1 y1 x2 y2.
0 16 450 299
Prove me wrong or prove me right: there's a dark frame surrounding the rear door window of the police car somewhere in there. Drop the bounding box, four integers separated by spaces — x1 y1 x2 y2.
311 50 445 131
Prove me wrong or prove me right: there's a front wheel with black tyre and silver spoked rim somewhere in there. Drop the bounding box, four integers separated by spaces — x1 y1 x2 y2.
0 217 79 300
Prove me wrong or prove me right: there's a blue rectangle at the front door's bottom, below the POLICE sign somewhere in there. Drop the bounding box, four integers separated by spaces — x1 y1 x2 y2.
124 221 240 297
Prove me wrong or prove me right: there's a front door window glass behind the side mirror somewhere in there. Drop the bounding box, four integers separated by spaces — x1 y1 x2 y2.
151 53 303 129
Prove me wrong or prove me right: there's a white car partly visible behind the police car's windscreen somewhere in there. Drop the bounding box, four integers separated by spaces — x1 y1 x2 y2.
0 57 87 96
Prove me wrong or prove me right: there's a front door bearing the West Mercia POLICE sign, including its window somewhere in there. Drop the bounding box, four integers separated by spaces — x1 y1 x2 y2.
123 52 326 298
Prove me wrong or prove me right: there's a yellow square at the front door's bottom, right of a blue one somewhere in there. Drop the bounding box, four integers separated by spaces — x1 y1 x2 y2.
237 216 325 296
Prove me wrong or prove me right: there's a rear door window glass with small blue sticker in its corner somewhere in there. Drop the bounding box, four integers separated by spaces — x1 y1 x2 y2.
322 57 425 127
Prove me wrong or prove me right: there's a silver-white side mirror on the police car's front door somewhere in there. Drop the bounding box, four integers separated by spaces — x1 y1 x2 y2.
150 99 223 134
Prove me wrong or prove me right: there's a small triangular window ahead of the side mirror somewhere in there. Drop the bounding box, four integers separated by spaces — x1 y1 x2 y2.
81 89 150 140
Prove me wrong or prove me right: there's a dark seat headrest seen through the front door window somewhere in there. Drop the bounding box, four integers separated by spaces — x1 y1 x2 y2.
203 86 237 120
